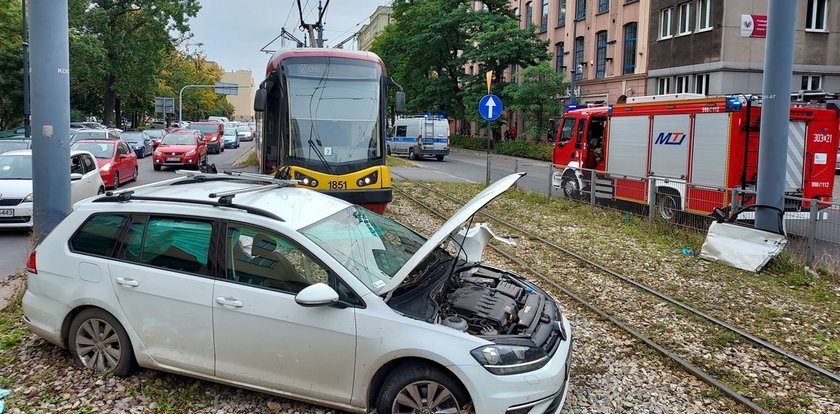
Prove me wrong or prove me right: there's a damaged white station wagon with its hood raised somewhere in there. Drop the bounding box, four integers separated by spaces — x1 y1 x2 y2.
23 172 572 414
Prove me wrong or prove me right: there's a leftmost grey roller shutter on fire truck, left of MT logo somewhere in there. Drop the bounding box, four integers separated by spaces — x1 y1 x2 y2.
607 115 650 178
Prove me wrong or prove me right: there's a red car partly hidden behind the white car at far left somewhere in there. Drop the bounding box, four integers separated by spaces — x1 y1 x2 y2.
71 139 137 188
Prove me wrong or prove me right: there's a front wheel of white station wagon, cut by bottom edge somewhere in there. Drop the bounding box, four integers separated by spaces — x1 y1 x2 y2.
376 365 470 414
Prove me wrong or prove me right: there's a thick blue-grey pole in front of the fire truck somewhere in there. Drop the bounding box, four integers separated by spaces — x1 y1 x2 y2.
755 0 798 233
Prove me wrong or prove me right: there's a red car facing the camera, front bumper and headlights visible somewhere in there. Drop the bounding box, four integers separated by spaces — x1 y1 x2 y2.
152 129 207 171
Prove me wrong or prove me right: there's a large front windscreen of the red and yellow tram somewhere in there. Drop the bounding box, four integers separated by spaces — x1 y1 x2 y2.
286 58 382 165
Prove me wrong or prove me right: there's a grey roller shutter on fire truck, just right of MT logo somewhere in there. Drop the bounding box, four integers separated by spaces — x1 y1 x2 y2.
691 112 740 188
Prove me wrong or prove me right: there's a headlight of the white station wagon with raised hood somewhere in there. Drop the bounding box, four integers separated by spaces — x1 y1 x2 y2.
470 344 549 375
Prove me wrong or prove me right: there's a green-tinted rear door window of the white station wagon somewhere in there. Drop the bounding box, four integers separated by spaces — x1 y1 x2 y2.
139 217 213 275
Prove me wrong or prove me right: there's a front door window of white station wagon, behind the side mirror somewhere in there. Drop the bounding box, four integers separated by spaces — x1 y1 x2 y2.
227 224 329 294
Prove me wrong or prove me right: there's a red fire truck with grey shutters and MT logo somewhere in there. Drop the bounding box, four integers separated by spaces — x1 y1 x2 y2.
552 94 840 220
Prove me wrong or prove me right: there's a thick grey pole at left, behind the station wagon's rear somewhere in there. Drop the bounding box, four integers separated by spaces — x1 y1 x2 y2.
30 0 71 241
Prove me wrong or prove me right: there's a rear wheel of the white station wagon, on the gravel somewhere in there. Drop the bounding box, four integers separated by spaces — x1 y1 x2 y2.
67 308 135 376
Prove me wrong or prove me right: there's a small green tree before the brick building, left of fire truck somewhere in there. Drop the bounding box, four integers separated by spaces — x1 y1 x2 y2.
503 61 567 142
